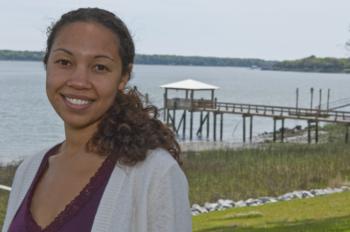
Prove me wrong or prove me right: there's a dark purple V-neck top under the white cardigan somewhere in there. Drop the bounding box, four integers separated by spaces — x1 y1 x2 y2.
9 145 115 232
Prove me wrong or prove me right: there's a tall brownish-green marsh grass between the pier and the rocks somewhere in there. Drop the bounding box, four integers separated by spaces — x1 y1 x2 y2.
184 143 350 204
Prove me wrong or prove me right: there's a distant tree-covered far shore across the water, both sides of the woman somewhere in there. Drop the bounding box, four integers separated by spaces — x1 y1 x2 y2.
0 50 350 73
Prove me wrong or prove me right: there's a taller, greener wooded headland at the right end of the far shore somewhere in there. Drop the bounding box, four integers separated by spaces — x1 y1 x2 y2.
272 56 350 73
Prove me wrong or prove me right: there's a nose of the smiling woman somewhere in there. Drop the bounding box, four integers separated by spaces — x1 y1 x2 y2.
67 65 91 89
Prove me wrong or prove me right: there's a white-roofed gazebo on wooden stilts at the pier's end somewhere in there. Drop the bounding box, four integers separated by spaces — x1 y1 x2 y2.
160 79 219 139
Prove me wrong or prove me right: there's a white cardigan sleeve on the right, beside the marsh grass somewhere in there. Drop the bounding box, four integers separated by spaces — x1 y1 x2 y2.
148 164 192 232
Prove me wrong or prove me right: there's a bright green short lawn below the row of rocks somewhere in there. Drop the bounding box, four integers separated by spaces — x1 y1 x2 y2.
193 192 350 232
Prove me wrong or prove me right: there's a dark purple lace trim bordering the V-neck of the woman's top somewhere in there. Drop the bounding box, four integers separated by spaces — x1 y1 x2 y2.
26 148 115 232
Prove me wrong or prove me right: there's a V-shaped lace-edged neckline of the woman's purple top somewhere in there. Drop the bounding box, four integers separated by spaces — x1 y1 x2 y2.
26 144 113 232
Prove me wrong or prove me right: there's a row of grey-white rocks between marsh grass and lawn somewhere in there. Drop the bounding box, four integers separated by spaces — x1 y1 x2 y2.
191 186 350 216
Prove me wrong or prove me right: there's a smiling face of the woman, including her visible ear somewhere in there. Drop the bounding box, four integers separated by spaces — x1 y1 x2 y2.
46 22 128 129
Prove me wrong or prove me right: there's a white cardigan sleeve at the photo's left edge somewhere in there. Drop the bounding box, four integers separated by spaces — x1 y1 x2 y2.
2 162 24 232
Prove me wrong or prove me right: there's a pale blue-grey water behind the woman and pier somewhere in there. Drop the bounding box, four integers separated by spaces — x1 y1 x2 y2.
0 61 350 162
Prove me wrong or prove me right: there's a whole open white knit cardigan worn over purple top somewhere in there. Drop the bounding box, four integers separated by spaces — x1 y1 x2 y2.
2 149 192 232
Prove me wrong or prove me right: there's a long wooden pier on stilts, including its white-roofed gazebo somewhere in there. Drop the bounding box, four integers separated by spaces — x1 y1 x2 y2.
162 80 350 143
